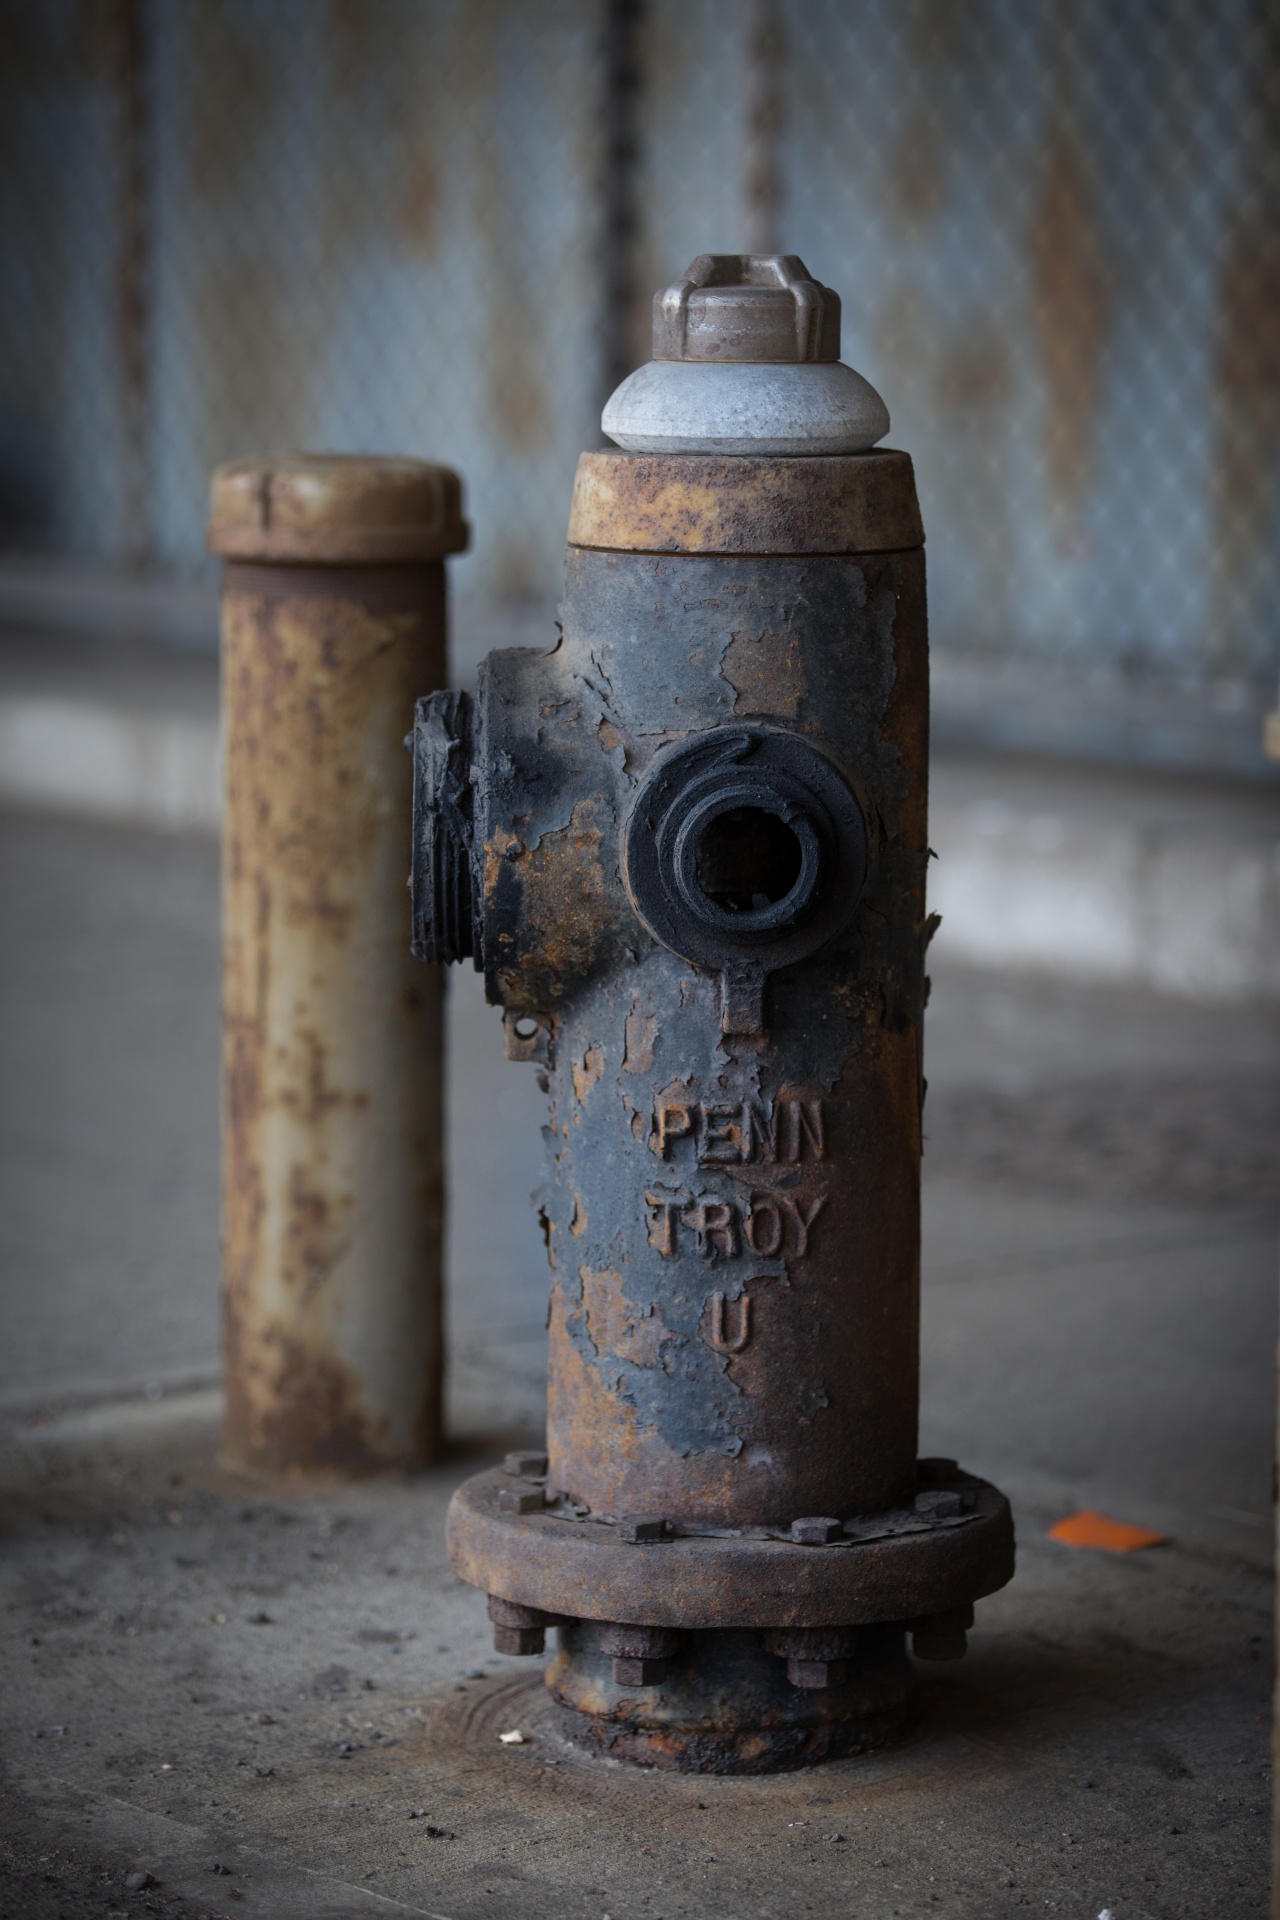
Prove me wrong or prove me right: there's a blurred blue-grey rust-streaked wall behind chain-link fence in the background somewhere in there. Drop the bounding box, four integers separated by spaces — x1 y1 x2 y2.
0 0 1280 776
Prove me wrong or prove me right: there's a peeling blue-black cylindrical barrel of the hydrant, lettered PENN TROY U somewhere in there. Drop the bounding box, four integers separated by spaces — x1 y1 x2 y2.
545 451 927 1526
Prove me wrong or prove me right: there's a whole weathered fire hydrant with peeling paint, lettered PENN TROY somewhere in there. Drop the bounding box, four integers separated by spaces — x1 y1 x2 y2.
413 255 1013 1772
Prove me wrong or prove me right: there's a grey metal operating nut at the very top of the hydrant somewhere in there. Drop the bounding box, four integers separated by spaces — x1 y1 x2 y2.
652 253 841 365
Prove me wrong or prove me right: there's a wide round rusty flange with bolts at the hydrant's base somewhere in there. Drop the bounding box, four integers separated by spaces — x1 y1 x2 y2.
447 1467 1013 1630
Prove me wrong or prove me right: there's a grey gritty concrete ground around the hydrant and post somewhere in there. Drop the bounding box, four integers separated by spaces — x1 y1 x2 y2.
0 814 1280 1920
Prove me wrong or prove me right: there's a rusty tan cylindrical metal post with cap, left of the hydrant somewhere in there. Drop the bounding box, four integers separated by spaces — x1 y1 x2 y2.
209 455 466 1473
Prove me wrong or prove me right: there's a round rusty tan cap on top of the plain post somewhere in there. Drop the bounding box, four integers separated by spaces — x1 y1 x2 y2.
205 453 470 566
